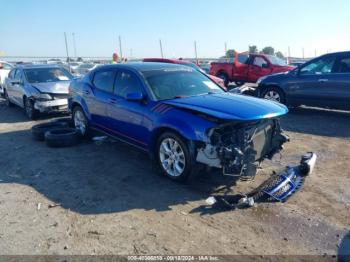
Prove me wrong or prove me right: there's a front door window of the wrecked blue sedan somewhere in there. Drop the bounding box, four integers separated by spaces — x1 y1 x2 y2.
114 71 142 97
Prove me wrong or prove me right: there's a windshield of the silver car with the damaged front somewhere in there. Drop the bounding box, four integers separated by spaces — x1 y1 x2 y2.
23 68 73 83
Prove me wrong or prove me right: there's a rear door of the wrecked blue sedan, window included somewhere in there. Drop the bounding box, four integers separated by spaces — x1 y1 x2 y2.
87 69 116 127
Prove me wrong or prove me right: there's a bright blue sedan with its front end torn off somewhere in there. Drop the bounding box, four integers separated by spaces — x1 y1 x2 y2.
68 63 288 180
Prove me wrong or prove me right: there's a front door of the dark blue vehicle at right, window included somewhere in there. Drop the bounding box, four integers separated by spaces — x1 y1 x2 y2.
288 56 336 106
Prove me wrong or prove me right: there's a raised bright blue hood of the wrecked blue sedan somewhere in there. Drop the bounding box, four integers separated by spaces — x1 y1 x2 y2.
163 93 288 121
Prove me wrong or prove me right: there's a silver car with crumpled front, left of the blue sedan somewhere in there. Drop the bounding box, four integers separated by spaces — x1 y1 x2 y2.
4 65 73 119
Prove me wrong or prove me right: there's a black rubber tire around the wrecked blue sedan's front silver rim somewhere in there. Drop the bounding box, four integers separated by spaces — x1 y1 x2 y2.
155 132 196 182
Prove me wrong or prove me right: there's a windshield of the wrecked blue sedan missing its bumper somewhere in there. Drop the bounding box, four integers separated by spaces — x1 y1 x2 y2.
142 68 224 100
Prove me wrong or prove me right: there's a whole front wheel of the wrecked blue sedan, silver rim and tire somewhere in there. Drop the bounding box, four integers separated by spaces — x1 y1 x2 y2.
156 132 193 181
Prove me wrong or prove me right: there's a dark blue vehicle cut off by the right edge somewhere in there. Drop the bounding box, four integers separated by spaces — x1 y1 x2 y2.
257 52 350 109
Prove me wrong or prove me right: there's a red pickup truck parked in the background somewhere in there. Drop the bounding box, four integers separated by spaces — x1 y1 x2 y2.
209 53 294 86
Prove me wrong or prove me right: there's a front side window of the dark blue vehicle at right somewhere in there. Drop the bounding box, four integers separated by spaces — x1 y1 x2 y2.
300 57 335 75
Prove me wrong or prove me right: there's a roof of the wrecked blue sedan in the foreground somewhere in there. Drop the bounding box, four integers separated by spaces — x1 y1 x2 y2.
94 62 193 72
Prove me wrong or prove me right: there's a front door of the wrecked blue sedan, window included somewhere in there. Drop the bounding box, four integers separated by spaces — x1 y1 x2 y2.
108 70 148 147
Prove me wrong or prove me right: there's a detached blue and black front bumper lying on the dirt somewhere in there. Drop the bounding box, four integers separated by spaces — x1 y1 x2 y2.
206 152 317 209
